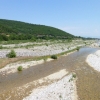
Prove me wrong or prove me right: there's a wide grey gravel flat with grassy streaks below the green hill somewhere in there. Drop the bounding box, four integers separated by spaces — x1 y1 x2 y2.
0 40 95 58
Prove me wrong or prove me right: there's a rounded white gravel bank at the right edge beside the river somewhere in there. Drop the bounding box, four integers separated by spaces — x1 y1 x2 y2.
86 50 100 72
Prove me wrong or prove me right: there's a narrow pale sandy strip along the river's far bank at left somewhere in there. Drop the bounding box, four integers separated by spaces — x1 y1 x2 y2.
0 58 53 75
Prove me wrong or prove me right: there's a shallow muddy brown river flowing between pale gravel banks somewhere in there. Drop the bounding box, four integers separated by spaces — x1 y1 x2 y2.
0 48 100 100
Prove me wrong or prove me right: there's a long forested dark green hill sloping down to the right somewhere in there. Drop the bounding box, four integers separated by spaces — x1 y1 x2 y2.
0 19 74 41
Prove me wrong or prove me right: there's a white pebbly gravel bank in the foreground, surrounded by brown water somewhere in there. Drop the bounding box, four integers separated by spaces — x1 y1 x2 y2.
23 70 77 100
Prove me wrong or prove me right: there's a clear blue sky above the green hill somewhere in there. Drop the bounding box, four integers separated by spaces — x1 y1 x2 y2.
0 0 100 38
